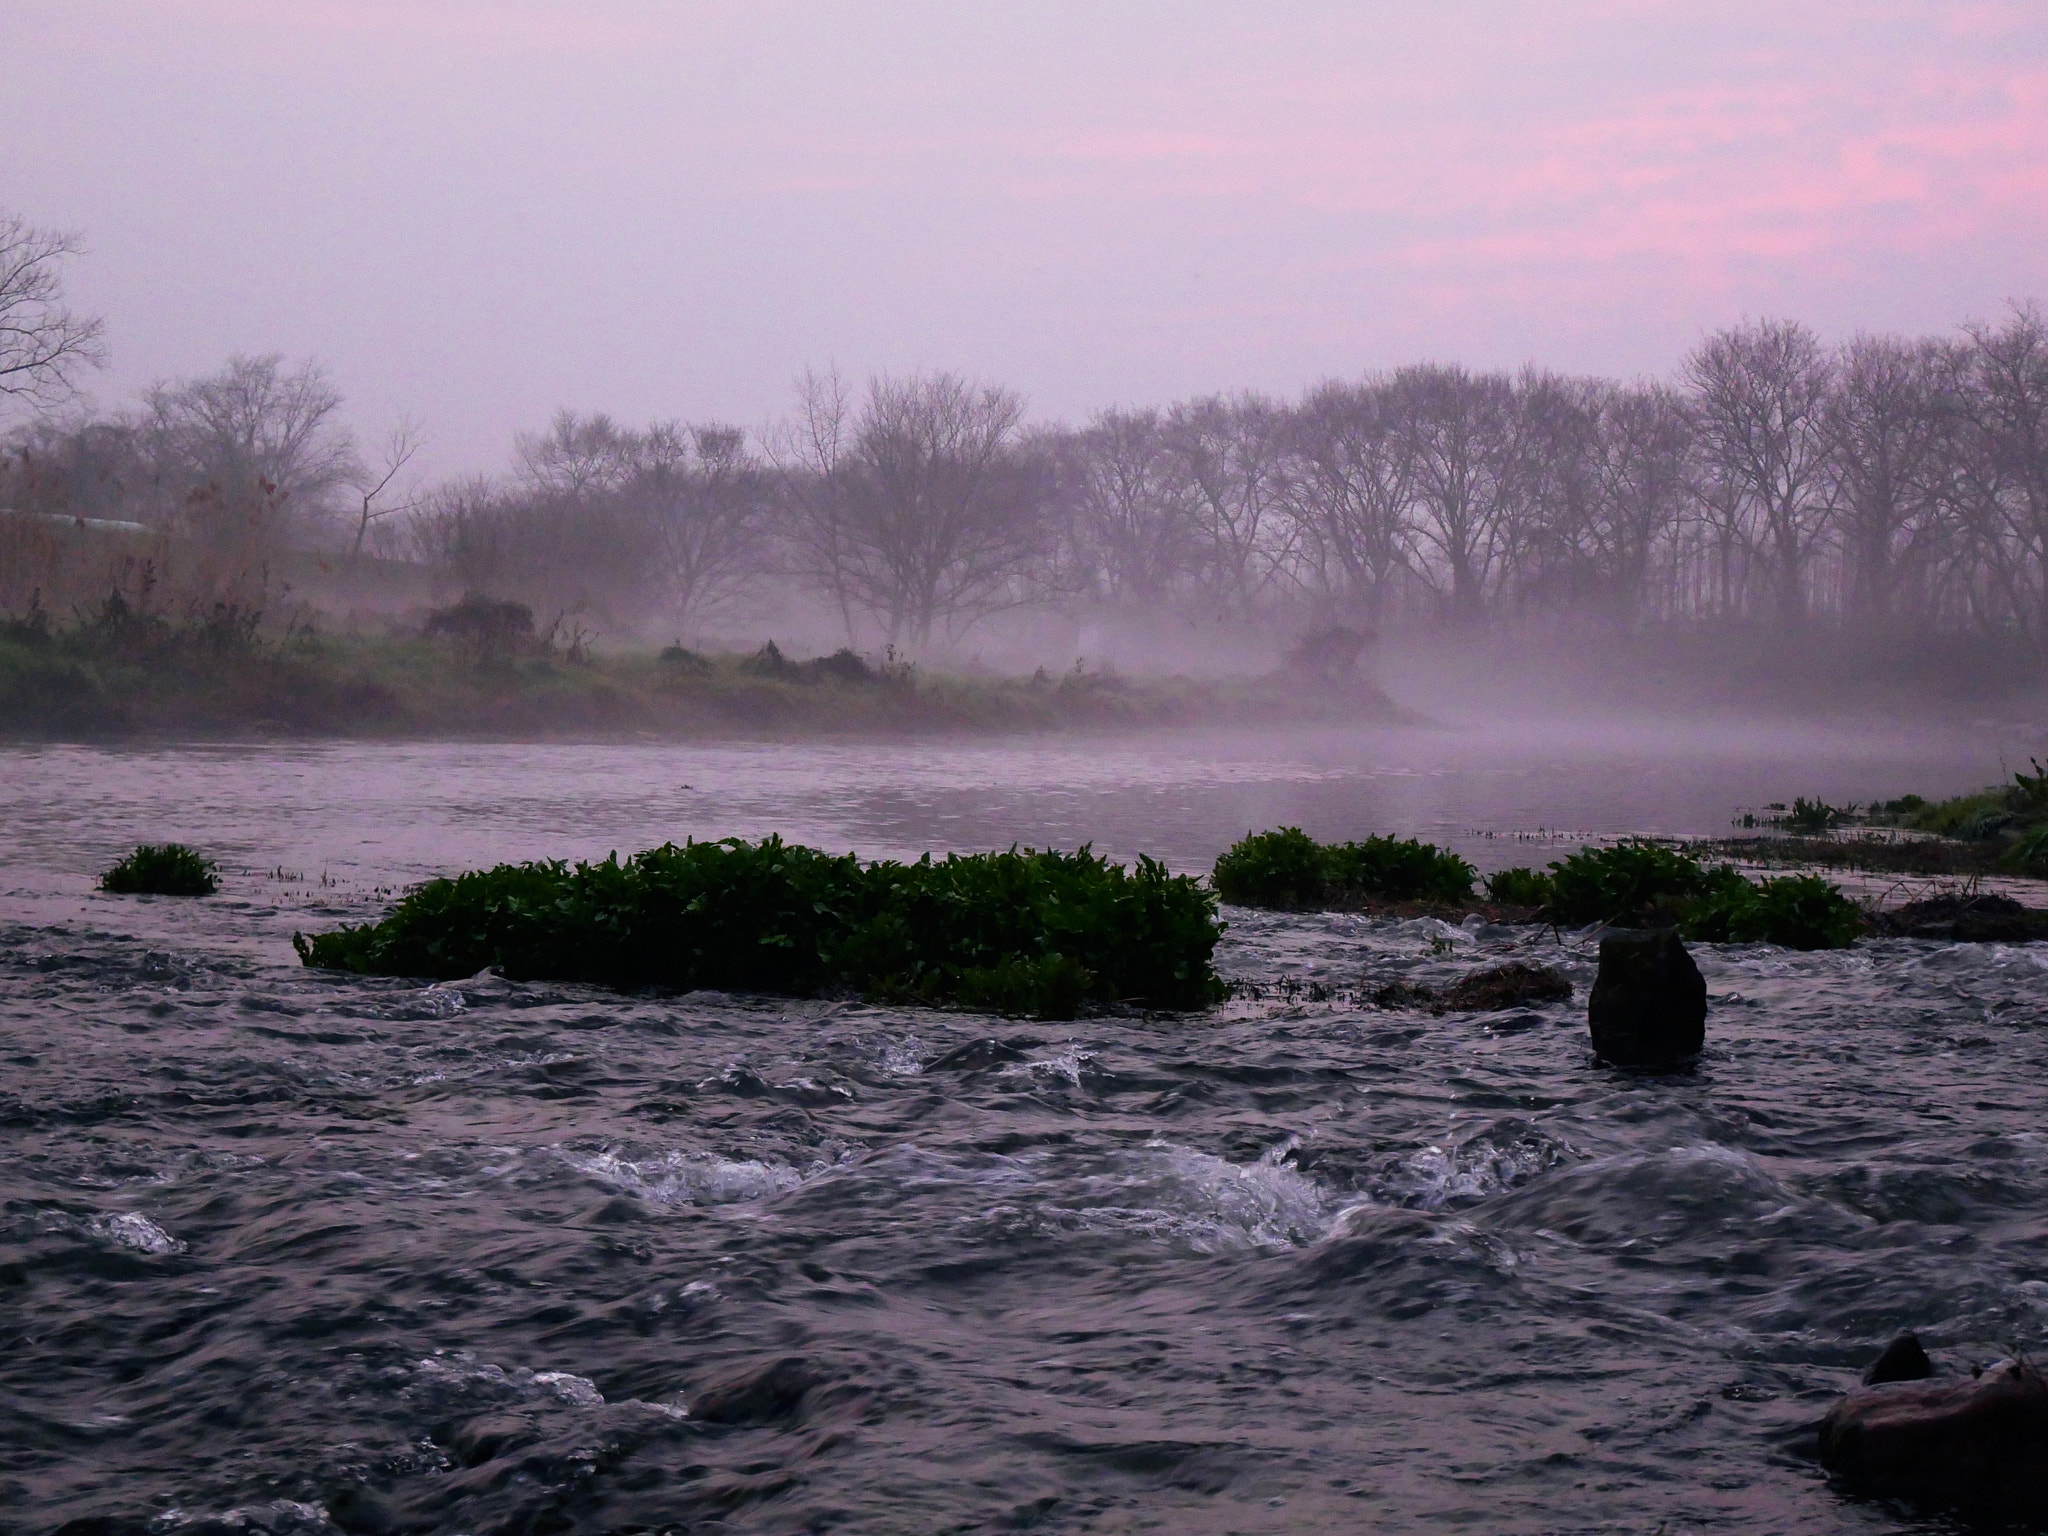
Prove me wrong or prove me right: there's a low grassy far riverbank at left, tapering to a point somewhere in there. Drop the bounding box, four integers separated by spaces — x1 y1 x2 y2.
0 600 1409 739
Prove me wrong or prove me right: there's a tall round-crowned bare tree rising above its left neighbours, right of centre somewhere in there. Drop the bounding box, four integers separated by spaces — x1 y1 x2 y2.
1686 319 1835 627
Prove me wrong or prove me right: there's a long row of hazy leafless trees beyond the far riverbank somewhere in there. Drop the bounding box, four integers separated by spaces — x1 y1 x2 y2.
0 207 2048 651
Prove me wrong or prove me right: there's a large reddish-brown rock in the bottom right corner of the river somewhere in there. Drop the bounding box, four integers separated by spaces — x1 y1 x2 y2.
1821 1360 2048 1518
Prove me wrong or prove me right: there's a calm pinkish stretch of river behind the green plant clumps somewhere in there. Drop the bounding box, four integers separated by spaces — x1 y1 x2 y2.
0 717 2032 913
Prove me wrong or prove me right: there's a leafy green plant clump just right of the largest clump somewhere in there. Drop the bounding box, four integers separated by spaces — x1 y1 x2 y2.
1210 827 1475 909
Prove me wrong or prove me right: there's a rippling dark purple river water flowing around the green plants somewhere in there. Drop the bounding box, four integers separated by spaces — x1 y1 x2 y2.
0 727 2048 1536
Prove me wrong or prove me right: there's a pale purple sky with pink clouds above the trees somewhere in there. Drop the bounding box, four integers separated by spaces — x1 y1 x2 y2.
0 0 2048 471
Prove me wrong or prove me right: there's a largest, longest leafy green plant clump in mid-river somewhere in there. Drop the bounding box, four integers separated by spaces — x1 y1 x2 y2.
293 838 1221 1018
